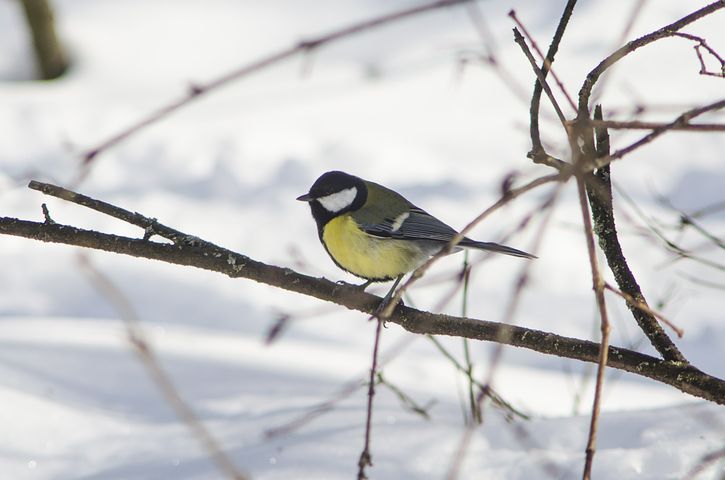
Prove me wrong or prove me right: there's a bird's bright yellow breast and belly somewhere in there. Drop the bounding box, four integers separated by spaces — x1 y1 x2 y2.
322 214 428 280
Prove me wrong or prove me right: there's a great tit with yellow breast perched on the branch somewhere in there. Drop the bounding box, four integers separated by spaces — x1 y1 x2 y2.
297 171 536 286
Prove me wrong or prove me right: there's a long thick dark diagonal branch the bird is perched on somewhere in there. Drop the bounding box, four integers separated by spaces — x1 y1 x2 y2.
0 217 725 405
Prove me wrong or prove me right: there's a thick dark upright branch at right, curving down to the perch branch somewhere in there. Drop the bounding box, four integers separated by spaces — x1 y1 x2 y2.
587 106 687 363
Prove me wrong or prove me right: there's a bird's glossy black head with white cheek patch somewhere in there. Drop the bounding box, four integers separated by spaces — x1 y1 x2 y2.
297 171 368 235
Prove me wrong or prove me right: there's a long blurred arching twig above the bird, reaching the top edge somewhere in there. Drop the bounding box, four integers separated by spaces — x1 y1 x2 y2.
82 0 471 171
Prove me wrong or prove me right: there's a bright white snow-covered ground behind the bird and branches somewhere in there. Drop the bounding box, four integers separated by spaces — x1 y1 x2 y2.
0 0 725 480
